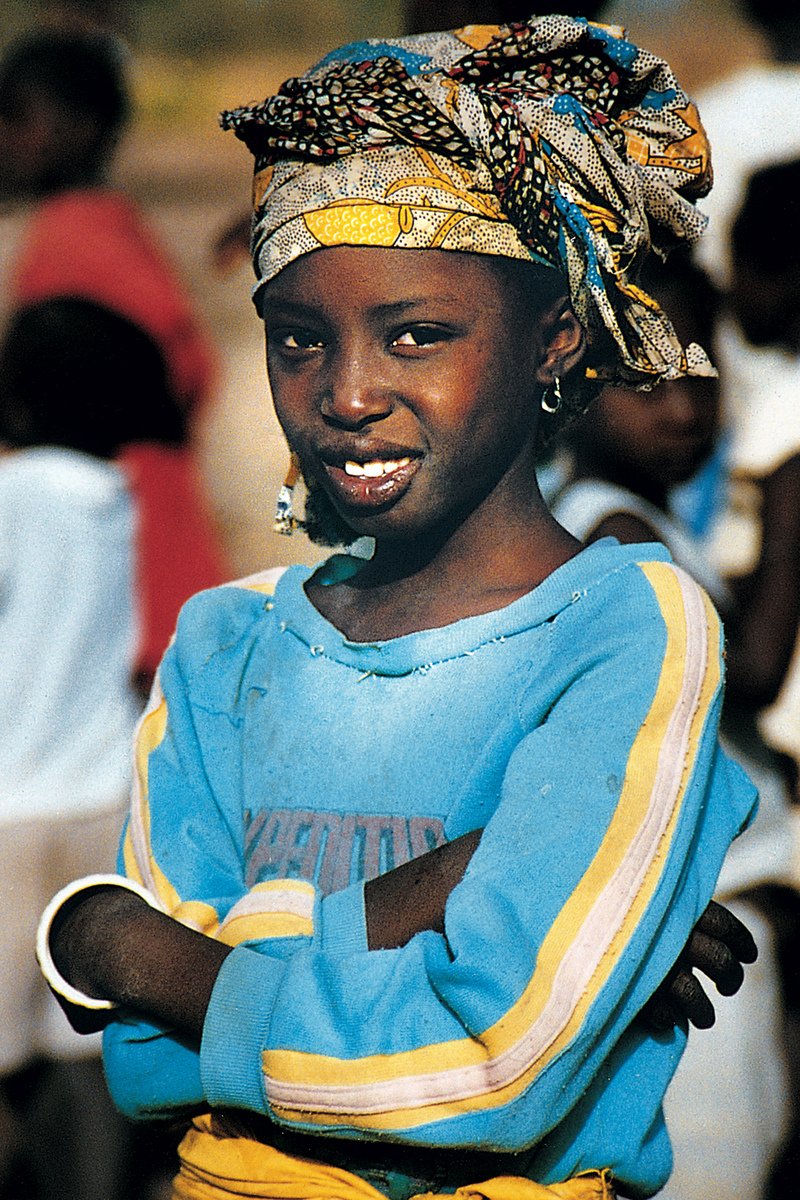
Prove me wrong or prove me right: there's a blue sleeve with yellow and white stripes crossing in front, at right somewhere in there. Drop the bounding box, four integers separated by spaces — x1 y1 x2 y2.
194 563 754 1151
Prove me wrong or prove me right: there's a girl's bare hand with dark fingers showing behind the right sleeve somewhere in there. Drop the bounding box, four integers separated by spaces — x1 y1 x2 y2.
643 900 758 1030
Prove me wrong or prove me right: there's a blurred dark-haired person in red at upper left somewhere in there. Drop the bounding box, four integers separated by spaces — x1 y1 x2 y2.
0 30 229 690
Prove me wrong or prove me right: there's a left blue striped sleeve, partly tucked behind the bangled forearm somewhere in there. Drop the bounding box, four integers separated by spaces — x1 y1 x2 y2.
119 583 357 953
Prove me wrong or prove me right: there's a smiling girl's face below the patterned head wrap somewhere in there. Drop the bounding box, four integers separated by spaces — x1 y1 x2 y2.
264 247 563 536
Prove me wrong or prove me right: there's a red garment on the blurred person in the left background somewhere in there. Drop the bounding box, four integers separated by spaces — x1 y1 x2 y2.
10 188 229 674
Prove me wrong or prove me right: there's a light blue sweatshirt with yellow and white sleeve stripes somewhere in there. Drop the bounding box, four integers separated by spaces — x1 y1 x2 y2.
106 540 754 1196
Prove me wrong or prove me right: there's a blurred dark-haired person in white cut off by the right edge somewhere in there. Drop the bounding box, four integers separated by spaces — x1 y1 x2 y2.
714 160 800 796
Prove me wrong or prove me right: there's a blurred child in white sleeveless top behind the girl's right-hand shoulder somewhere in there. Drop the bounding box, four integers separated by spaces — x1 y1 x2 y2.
551 254 800 1200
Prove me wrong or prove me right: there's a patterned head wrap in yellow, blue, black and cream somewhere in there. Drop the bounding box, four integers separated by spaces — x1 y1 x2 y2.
222 17 714 415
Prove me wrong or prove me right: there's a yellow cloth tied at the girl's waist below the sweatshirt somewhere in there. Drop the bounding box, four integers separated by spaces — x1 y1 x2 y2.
173 1115 614 1200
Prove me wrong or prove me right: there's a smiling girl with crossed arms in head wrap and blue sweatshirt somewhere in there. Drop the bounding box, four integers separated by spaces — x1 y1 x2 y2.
40 17 754 1200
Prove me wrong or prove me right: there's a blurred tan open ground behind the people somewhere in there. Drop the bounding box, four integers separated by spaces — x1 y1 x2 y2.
0 0 763 574
